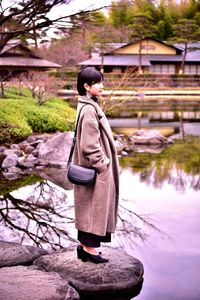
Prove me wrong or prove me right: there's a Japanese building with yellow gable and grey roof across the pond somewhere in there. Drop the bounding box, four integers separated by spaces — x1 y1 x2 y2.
79 38 200 75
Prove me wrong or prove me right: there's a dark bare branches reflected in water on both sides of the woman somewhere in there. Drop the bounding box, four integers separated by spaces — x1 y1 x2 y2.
0 181 161 249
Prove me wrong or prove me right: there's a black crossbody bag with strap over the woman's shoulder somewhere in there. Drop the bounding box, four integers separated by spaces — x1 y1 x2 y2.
67 104 97 186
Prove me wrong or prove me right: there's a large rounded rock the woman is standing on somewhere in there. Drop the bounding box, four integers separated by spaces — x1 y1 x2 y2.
34 247 143 299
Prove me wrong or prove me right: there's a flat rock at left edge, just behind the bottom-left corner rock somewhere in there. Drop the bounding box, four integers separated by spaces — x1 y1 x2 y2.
0 241 48 268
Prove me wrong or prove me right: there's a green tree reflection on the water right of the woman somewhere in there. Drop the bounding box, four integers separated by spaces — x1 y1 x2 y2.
121 137 200 192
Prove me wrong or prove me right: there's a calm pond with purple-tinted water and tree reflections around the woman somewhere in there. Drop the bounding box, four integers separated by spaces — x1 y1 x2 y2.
0 115 200 300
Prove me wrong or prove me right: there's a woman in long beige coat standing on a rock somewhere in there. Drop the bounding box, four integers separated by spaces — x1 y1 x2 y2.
73 67 119 263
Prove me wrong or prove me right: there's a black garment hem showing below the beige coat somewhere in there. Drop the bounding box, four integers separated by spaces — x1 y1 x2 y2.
78 230 111 248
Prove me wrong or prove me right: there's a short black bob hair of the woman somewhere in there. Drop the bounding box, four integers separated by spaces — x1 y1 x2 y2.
77 67 103 96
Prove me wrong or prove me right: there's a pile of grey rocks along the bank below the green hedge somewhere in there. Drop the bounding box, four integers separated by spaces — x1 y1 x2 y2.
0 132 73 180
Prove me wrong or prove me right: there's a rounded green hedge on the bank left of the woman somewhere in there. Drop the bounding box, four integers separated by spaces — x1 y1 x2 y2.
0 88 76 143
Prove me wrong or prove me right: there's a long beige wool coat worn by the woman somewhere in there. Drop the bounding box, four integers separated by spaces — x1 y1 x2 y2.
73 96 119 236
